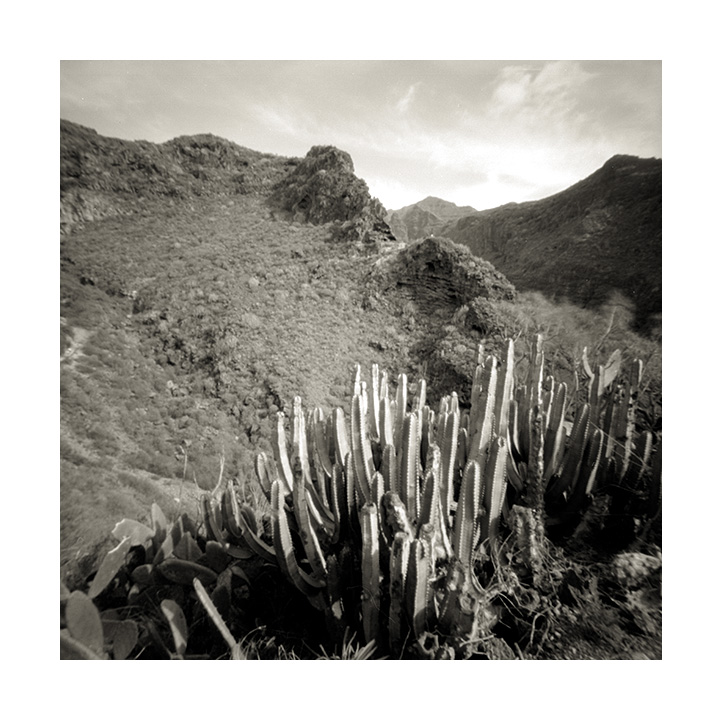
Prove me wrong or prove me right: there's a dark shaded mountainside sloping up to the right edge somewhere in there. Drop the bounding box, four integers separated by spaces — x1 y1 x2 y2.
389 155 662 330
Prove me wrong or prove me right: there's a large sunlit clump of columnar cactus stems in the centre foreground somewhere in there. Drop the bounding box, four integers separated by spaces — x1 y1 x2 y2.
211 343 513 651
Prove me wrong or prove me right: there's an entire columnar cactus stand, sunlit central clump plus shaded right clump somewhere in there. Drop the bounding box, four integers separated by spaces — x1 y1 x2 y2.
217 337 651 652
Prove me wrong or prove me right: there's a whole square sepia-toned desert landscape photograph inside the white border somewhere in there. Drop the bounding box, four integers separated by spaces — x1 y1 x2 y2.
59 58 660 667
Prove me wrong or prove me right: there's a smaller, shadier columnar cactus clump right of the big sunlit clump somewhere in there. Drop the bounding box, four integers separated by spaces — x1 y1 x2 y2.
496 336 660 536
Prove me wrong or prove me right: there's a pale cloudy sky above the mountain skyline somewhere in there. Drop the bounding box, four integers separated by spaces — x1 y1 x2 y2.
60 60 662 210
